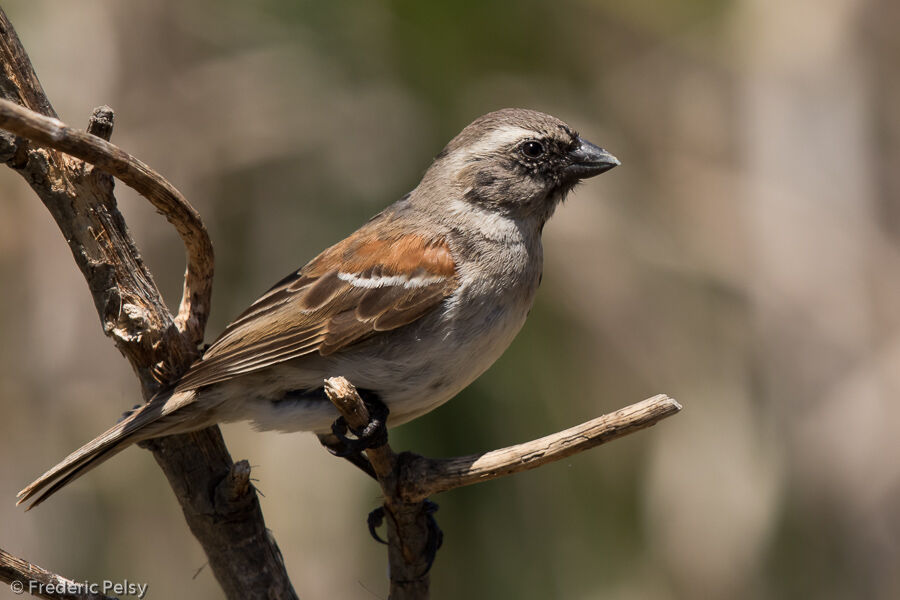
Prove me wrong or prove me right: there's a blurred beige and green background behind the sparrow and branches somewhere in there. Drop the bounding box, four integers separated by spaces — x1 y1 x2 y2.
0 0 900 600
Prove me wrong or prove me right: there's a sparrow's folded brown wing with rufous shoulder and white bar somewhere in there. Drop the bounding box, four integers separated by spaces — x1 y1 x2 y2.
175 227 458 391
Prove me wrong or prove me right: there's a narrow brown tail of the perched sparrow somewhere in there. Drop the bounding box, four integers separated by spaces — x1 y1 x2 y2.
16 395 175 510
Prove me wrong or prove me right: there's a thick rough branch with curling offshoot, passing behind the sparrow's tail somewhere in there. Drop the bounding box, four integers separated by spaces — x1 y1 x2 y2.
0 9 297 600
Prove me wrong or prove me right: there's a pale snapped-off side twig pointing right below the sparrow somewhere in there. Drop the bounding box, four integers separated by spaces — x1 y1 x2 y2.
400 394 681 502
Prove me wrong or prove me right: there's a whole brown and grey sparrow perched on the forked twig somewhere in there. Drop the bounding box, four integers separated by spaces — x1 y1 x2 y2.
18 108 619 508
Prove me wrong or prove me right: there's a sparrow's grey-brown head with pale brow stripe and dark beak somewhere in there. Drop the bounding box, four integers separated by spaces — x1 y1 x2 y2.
423 108 619 224
